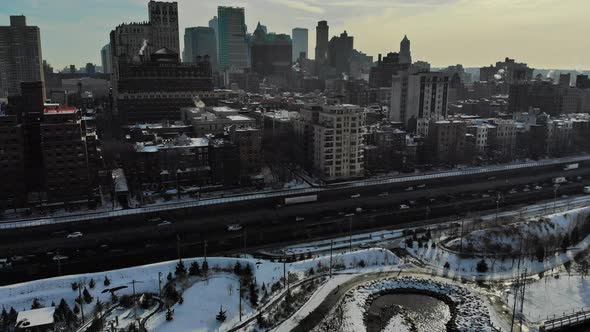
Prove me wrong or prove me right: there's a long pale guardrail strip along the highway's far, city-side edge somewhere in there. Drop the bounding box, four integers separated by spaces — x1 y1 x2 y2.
0 156 590 230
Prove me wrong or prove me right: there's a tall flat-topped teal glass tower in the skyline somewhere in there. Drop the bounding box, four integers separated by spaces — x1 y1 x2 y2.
217 6 249 70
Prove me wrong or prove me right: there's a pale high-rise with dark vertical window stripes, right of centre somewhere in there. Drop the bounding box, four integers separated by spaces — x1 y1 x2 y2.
389 72 449 131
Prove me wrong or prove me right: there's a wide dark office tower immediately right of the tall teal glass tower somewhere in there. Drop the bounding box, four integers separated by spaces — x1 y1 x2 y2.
251 23 292 78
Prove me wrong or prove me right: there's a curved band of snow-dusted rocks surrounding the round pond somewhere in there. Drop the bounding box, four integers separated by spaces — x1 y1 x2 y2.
320 277 492 332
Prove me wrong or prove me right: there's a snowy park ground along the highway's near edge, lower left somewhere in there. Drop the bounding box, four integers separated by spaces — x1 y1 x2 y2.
0 249 398 331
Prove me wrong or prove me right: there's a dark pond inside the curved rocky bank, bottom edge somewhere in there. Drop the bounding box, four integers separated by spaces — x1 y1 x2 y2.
367 293 451 332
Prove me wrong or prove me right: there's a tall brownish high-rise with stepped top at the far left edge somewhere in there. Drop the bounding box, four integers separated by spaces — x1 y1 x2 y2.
0 15 44 97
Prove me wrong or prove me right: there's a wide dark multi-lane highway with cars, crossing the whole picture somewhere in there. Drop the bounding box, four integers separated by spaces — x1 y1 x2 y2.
0 168 590 284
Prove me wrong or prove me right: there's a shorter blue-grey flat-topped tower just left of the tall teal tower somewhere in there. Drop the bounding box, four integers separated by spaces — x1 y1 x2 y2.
182 27 217 69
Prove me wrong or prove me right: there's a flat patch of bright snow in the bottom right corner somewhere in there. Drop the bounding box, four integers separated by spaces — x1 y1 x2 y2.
504 273 590 322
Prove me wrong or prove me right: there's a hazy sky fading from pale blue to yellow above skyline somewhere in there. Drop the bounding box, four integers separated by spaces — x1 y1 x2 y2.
0 0 590 70
